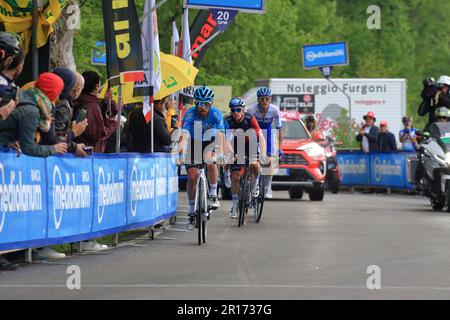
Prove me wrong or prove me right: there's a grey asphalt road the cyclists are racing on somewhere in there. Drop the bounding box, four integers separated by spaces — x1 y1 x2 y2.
0 192 450 300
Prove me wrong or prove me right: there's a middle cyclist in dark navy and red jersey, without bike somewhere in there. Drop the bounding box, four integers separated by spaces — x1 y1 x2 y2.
224 98 266 219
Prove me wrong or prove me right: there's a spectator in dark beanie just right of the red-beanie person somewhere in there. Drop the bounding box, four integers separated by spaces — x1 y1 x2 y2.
53 68 88 157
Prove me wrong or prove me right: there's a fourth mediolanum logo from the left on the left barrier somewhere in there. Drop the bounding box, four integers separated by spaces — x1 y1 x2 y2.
130 165 155 217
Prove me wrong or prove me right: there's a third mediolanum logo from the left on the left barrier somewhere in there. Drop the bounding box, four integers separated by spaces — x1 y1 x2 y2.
97 166 125 224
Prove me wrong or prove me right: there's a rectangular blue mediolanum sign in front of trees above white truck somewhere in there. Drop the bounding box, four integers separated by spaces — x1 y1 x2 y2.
303 42 349 69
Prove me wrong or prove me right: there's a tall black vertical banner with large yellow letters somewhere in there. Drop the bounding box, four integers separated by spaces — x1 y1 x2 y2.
102 0 145 86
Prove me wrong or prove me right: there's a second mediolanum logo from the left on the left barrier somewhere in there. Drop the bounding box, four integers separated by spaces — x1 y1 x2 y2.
53 165 91 230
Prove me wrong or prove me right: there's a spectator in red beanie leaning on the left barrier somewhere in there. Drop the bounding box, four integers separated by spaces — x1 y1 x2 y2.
0 73 67 157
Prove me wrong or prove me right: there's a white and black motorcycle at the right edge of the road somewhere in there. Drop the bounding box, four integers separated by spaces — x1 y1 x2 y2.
410 123 450 212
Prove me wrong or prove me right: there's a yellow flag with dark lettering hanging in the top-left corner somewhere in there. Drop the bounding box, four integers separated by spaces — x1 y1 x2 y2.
0 0 67 52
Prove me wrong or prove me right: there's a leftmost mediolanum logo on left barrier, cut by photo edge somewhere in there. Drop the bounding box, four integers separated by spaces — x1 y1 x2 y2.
0 162 42 233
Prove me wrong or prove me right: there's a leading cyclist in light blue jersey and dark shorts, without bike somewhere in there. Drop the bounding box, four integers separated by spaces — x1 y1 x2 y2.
180 86 225 230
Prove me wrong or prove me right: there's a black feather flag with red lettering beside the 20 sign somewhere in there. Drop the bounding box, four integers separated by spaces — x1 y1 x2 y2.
190 10 219 67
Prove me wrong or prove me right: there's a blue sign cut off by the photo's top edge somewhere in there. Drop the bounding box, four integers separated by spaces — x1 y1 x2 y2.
184 0 266 13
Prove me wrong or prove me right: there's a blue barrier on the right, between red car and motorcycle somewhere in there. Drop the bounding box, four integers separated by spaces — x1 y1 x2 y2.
337 152 414 190
